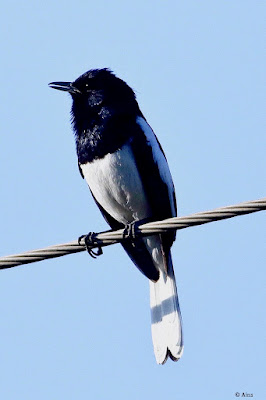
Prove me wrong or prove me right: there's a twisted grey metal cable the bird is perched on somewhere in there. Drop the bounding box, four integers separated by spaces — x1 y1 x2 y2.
0 198 266 269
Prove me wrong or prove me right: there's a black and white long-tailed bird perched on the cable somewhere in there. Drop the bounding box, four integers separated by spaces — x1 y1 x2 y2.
49 68 183 364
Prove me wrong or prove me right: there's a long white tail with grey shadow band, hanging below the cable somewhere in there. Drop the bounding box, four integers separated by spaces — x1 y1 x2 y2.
150 254 183 364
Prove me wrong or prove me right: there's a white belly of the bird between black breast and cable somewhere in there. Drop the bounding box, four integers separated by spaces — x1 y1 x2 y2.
81 144 151 224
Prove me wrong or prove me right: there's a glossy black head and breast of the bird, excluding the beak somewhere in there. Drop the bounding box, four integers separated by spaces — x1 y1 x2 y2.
68 69 142 164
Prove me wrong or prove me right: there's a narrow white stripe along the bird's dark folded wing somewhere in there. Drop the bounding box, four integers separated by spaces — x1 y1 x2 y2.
136 117 176 216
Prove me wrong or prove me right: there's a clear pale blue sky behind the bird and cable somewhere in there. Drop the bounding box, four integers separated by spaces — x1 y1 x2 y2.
0 0 266 400
